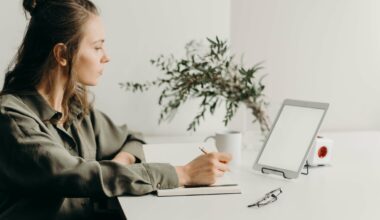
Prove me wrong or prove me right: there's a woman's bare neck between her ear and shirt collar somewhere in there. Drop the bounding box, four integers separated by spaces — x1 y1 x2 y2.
36 69 67 112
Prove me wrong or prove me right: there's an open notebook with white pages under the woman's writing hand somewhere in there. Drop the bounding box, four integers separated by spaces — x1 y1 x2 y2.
143 143 241 196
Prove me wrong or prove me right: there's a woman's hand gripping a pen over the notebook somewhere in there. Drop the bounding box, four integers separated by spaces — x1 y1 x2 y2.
176 152 232 186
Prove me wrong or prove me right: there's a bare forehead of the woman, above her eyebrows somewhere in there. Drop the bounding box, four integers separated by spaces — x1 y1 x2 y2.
83 14 105 43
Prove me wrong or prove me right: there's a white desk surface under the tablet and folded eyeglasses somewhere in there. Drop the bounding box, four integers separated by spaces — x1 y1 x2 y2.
119 132 380 220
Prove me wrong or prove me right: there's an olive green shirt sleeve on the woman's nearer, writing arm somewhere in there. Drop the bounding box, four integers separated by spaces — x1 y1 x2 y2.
0 109 178 197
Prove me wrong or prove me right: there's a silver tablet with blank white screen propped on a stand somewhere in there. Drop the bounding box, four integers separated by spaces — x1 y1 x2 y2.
253 99 329 179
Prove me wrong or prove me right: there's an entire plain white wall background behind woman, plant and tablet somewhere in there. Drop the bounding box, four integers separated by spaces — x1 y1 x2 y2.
0 0 380 138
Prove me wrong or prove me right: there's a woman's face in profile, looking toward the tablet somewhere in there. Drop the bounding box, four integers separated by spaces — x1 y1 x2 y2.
73 15 110 86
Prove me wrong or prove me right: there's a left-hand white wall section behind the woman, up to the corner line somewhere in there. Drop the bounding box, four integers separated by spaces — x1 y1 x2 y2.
0 0 230 134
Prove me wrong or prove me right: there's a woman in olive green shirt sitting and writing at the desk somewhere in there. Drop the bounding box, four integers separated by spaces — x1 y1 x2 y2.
0 0 231 219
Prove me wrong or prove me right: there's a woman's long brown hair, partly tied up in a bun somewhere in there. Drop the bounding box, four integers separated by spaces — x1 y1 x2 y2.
1 0 99 121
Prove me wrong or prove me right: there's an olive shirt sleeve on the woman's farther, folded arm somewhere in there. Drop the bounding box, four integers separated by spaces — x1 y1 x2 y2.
90 109 145 162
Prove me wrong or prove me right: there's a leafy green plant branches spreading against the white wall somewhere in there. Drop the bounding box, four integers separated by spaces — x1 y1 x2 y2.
120 37 269 134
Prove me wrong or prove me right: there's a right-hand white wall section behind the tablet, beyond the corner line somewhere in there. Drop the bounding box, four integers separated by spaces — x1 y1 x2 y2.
231 0 380 130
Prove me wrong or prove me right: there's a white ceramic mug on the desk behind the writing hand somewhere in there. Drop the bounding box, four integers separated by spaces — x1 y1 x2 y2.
205 131 242 166
